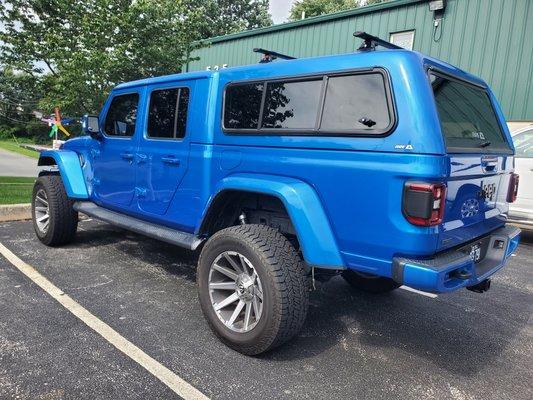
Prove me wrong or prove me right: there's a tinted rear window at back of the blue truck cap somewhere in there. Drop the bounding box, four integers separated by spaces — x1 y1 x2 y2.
430 73 510 152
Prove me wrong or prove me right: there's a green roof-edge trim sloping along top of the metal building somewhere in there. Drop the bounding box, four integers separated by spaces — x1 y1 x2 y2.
202 0 428 43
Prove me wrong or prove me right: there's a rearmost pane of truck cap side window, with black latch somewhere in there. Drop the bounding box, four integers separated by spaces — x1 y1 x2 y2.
320 74 391 133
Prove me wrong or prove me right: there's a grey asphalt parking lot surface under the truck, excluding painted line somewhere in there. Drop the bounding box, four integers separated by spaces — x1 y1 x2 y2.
0 221 533 399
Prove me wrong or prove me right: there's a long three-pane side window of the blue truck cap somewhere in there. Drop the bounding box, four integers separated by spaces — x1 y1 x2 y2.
223 71 394 136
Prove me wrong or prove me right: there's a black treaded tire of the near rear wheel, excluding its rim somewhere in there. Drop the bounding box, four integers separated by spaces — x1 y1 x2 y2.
197 224 309 355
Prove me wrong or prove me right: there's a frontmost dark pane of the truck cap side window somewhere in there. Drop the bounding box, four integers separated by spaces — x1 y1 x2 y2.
224 83 263 129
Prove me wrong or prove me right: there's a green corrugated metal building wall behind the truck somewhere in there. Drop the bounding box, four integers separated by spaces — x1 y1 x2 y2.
188 0 533 121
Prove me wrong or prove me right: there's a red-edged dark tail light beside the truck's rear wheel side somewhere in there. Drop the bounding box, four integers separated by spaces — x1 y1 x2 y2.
402 182 446 226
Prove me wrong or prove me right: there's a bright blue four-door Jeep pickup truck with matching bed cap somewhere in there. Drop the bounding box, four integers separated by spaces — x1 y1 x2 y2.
32 35 520 355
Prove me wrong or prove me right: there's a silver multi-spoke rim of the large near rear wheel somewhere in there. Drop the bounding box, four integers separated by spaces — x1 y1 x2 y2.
208 251 263 333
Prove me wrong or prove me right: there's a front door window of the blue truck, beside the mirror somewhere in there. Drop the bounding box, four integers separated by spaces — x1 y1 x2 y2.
104 93 139 136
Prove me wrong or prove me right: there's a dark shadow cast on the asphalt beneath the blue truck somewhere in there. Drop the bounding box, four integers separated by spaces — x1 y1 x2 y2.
71 225 531 376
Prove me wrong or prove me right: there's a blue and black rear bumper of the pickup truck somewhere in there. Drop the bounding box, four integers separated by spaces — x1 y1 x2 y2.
392 226 520 293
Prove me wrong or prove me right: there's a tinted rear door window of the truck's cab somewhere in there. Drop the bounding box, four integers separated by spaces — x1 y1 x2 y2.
148 88 189 139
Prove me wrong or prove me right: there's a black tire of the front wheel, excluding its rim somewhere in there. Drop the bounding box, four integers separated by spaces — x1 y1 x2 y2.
31 175 78 246
